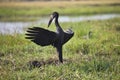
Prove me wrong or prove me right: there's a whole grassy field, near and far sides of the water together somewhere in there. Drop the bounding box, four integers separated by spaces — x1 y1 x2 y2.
0 0 120 80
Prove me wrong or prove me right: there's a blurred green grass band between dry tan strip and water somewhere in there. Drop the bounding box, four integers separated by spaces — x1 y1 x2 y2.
0 6 120 17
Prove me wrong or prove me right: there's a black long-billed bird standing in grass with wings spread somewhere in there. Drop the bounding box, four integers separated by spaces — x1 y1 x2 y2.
26 12 74 63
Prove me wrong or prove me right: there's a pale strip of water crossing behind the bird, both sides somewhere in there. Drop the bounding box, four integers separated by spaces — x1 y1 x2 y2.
0 14 120 34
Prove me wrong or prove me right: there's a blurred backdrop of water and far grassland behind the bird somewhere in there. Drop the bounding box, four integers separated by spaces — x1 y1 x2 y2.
0 0 120 34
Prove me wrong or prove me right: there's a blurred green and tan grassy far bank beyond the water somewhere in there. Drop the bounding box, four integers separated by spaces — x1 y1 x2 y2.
0 0 120 21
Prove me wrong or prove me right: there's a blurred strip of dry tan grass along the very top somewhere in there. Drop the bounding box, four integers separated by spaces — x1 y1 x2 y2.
0 0 120 7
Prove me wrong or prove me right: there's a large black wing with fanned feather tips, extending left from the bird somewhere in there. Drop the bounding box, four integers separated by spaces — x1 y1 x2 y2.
25 27 57 46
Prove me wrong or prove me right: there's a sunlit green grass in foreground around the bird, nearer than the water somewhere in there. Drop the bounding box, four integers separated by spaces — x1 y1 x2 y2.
0 18 120 80
